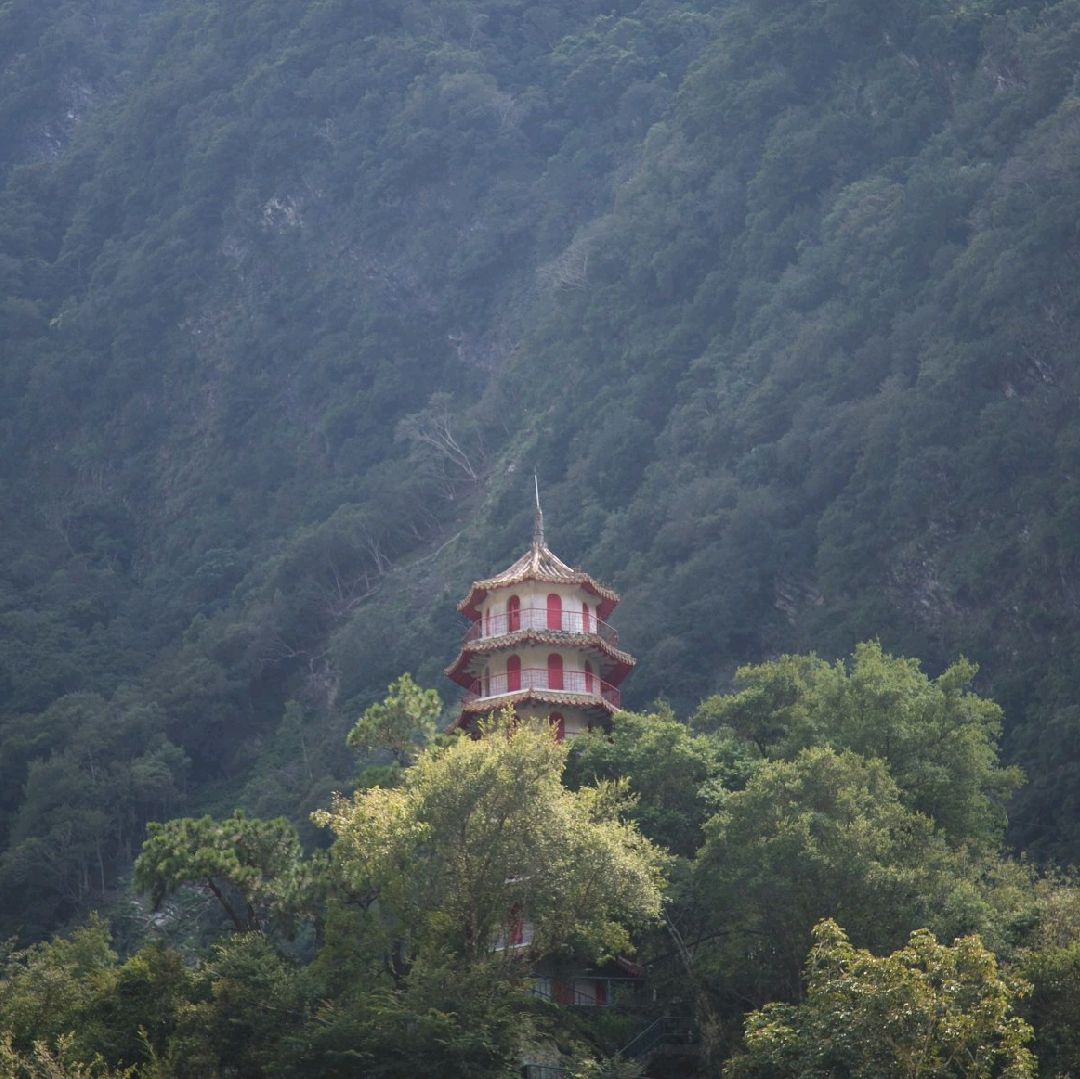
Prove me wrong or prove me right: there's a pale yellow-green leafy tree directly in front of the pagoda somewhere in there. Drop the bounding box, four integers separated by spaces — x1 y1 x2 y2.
314 715 663 969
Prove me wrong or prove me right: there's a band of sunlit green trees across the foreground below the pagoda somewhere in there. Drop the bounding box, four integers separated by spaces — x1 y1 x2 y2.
0 645 1080 1079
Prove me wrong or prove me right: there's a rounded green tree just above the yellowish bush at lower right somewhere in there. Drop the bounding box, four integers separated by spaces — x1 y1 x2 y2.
690 748 1010 1009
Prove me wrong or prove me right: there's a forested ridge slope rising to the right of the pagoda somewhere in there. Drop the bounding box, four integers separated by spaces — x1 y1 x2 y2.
475 2 1080 859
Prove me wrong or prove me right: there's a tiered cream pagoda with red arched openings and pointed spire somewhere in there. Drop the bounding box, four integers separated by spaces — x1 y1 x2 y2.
446 488 634 739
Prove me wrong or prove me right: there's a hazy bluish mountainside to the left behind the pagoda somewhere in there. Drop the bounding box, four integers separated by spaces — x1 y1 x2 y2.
0 2 712 937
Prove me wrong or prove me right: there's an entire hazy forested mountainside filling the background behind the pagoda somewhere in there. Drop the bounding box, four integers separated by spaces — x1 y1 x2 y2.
0 0 1080 934
